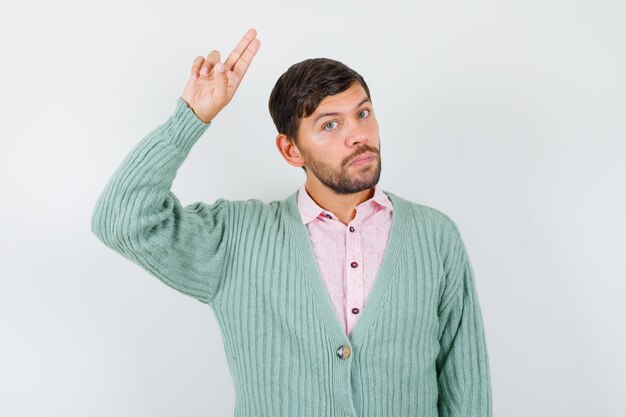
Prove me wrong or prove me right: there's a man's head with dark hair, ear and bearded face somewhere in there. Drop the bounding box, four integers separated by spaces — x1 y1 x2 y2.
269 58 381 194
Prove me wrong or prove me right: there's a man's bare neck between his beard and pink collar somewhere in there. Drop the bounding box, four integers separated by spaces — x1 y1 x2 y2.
305 178 374 224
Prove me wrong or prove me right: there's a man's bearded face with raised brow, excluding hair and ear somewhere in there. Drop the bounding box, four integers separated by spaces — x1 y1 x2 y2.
296 83 381 194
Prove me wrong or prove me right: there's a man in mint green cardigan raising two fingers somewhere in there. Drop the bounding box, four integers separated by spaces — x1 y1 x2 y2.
92 29 491 417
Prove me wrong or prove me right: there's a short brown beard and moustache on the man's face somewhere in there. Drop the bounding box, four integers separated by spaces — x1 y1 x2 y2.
301 145 381 194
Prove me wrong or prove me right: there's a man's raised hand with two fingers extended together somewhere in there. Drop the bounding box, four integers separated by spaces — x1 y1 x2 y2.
181 29 261 123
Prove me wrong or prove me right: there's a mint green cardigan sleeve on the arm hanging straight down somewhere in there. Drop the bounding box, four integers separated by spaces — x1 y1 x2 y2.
436 222 492 417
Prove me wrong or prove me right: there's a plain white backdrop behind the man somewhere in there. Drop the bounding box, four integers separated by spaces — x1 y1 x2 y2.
0 0 626 417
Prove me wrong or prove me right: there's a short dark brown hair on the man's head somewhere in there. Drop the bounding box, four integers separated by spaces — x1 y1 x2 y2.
269 58 371 142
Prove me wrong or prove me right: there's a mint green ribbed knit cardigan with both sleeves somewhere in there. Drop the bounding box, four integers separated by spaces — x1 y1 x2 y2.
92 98 492 417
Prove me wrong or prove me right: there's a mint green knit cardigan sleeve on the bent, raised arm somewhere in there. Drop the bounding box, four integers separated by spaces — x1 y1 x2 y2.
91 98 228 303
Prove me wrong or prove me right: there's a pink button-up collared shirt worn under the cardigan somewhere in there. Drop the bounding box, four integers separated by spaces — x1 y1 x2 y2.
297 184 393 335
